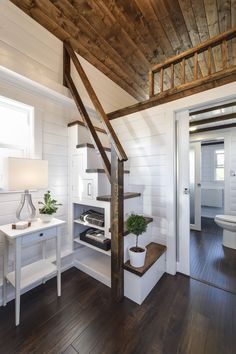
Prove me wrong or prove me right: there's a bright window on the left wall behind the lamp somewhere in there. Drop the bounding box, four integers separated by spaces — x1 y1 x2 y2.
0 96 34 189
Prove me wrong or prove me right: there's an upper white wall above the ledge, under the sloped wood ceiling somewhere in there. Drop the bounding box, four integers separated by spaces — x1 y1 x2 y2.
0 0 136 112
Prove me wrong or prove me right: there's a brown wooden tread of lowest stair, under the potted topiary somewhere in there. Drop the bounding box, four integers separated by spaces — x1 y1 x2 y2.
123 242 166 277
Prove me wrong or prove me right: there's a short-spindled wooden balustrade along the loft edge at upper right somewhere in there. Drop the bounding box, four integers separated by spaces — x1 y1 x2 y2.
149 27 236 98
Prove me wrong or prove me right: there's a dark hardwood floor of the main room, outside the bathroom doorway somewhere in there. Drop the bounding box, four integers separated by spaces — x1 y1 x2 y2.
0 268 236 354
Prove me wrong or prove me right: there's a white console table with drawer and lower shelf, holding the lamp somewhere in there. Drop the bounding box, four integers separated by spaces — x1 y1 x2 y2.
0 218 65 326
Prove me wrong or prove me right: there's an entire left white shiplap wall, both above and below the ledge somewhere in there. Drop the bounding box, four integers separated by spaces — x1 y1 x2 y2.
0 0 136 302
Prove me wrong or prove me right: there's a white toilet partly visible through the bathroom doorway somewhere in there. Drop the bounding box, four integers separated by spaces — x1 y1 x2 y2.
215 215 236 249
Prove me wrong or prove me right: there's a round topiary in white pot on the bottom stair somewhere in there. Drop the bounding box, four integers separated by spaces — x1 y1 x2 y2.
126 214 147 268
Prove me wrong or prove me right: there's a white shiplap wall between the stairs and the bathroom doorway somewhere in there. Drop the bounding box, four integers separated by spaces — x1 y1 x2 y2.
112 107 174 272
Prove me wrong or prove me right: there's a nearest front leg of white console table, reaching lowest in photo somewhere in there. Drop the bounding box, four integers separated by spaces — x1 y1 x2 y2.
15 237 21 326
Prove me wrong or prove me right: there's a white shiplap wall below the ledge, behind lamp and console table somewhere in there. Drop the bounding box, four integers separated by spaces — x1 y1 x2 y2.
0 75 75 284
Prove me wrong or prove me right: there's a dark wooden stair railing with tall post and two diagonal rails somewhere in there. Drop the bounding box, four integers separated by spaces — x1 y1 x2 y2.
63 43 125 300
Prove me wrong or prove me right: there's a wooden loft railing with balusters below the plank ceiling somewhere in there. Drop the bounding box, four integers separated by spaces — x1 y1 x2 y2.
149 28 236 98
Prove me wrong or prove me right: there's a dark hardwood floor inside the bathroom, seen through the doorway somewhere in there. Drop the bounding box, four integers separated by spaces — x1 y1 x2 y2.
190 218 236 294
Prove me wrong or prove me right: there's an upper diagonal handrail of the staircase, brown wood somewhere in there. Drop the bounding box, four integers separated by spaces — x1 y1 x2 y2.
64 43 128 161
